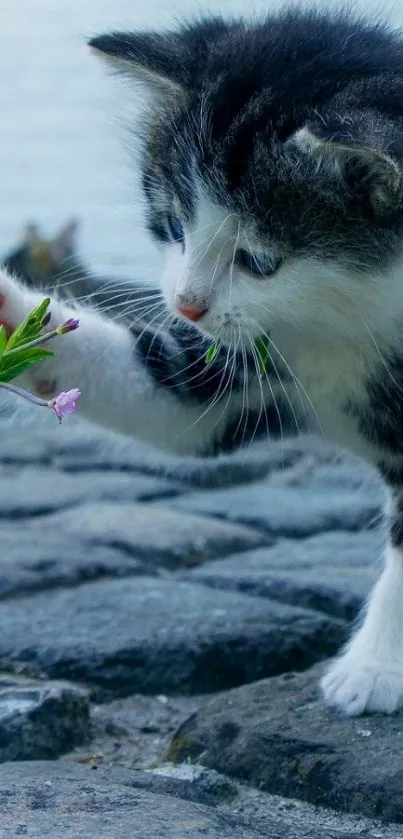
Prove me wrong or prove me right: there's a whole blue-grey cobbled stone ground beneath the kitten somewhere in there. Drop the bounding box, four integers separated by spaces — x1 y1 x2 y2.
0 418 403 839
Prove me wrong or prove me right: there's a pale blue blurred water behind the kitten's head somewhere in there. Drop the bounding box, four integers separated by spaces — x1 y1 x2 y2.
0 0 403 280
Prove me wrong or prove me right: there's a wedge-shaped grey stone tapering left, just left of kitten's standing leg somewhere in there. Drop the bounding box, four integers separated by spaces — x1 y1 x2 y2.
180 530 384 620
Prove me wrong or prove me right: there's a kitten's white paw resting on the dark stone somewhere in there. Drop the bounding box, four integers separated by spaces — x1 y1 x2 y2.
321 650 403 716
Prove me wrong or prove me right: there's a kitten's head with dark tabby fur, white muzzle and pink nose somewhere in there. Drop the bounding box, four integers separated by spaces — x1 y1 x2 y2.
91 9 403 343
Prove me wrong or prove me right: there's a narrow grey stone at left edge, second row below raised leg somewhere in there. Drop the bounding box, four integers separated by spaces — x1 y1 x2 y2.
0 466 178 519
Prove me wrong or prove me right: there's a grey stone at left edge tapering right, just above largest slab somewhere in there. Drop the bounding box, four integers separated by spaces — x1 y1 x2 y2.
0 522 145 600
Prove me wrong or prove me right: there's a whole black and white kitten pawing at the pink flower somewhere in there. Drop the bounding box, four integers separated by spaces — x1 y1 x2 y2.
0 8 403 714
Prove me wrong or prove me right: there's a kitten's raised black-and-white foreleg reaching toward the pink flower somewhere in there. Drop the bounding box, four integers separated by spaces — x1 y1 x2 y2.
0 271 266 455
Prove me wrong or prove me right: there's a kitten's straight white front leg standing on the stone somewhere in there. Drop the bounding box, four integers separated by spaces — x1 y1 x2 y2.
322 488 403 715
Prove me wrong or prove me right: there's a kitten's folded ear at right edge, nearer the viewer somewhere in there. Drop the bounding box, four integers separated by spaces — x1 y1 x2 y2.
293 126 403 216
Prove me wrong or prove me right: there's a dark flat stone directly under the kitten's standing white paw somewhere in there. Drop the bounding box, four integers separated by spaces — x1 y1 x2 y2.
168 667 403 824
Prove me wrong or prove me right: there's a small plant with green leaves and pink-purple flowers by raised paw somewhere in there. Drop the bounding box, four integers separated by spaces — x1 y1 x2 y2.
0 297 80 422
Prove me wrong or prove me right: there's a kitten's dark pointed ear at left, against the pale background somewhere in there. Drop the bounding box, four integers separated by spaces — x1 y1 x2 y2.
89 17 226 96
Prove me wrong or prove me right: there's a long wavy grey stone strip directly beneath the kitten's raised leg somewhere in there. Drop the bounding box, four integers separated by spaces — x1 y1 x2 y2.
0 422 334 488
